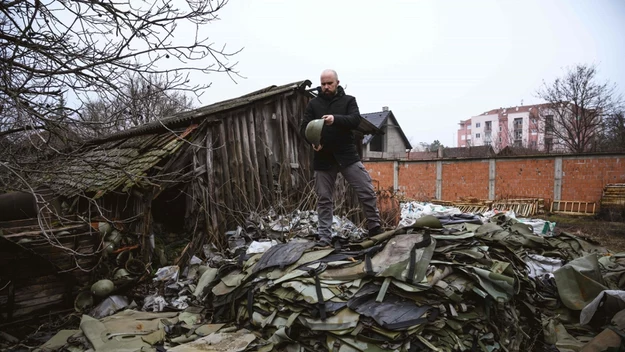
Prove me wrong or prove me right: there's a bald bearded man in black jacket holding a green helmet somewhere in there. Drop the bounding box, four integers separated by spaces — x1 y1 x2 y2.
300 70 381 244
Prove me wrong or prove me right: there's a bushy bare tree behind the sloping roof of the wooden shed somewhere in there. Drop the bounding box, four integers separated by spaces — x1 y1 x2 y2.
81 74 193 137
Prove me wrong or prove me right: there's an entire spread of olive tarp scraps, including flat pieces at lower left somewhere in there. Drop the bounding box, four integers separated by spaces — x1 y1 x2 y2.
26 208 625 352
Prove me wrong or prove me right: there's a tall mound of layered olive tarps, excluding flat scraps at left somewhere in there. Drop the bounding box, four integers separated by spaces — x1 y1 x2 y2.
199 210 624 351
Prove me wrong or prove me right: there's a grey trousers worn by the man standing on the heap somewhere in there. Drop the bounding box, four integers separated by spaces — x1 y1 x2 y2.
315 161 380 238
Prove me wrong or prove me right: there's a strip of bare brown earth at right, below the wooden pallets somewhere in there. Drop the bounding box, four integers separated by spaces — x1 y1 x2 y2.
540 215 625 253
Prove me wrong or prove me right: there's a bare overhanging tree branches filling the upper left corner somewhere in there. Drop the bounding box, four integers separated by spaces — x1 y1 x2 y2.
0 0 237 140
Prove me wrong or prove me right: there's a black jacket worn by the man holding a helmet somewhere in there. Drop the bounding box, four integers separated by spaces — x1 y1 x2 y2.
300 86 361 170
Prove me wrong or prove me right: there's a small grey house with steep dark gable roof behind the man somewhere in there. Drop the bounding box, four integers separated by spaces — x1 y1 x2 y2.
361 106 412 160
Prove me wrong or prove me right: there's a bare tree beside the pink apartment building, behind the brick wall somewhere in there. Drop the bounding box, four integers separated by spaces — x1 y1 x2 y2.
537 65 621 153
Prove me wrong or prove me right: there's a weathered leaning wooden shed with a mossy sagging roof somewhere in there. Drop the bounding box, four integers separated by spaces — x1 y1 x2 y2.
40 80 378 235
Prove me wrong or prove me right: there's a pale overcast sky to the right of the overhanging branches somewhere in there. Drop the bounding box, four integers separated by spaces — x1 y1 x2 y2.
186 0 625 146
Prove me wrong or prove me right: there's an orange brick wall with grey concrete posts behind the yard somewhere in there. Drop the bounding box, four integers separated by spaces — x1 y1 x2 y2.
365 154 625 206
